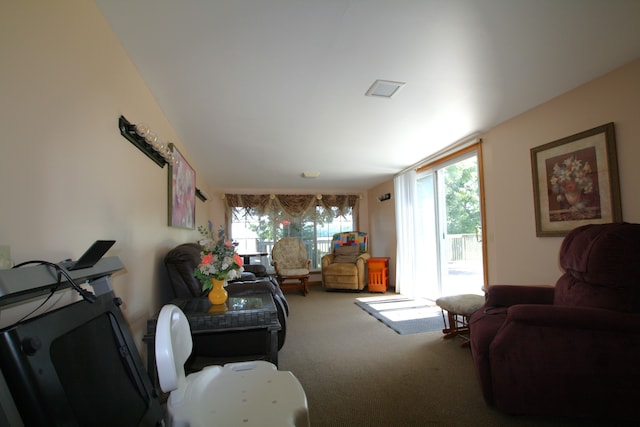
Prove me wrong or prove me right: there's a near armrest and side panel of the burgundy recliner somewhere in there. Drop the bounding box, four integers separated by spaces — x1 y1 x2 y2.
484 304 640 419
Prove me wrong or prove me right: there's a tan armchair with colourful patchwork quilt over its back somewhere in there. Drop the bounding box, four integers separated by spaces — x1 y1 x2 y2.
322 231 371 291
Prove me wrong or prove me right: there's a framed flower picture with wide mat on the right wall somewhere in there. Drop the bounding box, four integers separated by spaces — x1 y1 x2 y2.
531 123 622 237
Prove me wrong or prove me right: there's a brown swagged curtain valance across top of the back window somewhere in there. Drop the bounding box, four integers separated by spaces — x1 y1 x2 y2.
223 194 360 218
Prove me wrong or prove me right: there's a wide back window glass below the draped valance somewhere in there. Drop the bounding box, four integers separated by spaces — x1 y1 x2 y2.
231 206 355 270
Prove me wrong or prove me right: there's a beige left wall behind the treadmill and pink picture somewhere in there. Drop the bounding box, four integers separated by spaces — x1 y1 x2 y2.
0 0 214 352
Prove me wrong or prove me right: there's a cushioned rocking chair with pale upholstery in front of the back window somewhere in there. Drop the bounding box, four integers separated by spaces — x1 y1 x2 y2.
271 237 311 295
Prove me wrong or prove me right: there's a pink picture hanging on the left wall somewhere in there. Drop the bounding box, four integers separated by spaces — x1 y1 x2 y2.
169 143 196 230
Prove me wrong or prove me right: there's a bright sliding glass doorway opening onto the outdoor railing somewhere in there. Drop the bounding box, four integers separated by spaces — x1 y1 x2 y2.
416 149 485 299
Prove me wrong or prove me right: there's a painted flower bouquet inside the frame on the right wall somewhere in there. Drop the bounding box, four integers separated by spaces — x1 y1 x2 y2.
549 156 593 206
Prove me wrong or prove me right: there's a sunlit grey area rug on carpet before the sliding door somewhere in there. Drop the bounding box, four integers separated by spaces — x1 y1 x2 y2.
355 295 444 335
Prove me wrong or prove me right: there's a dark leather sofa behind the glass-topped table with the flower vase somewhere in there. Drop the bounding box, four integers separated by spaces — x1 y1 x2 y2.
164 243 289 357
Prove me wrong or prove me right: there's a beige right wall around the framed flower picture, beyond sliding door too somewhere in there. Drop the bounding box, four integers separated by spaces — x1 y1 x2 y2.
369 60 640 285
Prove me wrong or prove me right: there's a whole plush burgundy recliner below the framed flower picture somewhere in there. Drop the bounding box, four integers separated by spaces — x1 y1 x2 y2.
470 223 640 420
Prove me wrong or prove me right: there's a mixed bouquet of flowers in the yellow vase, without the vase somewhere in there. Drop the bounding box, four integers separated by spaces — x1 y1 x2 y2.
194 221 244 291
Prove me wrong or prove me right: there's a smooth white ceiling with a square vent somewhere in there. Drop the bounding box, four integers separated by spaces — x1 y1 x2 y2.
96 0 640 191
